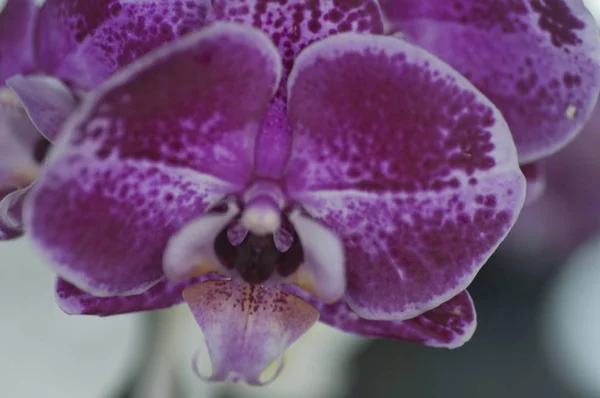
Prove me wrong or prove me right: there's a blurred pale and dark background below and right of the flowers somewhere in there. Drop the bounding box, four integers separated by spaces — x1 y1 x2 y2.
0 0 600 398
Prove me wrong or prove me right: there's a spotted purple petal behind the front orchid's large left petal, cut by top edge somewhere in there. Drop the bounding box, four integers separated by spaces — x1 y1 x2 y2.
35 0 208 89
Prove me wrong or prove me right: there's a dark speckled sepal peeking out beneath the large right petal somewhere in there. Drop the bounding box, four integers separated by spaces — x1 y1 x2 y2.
293 289 477 348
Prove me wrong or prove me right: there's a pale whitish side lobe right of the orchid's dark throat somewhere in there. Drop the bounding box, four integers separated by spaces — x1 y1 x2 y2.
289 212 346 303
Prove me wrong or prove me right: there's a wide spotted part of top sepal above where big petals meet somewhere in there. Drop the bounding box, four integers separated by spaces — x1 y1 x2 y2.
207 0 383 71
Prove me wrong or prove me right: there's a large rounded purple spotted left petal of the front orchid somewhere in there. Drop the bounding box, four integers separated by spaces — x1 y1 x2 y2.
25 24 280 296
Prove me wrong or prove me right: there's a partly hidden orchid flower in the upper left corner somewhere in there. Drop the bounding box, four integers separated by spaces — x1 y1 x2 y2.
0 0 208 239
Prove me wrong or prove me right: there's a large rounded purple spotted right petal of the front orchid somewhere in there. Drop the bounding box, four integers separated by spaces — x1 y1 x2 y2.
286 33 525 320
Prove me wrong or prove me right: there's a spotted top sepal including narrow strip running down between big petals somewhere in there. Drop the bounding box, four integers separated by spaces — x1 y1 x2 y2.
207 0 383 179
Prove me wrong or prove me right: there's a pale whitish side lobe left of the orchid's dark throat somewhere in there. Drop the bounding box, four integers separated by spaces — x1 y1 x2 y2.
163 205 239 281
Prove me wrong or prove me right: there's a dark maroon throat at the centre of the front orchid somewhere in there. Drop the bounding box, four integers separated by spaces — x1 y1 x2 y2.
215 216 304 285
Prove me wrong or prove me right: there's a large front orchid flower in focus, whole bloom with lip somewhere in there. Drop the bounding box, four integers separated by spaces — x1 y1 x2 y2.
24 0 525 384
